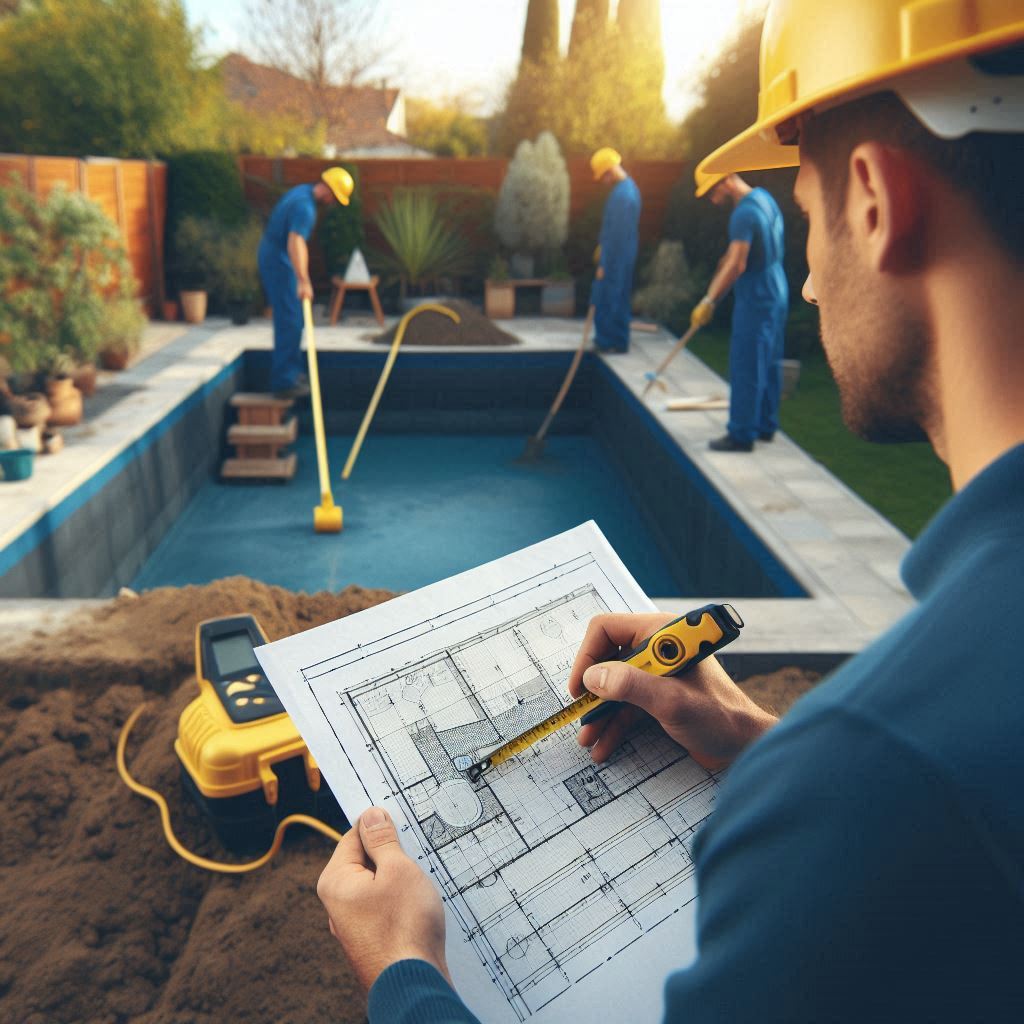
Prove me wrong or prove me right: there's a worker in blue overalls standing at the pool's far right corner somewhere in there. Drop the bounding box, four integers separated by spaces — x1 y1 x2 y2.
590 146 640 352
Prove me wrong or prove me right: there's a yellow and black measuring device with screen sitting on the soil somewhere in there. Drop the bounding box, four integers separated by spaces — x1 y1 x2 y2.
174 614 347 852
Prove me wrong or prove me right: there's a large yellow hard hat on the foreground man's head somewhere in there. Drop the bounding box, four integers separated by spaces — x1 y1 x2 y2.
694 0 1024 196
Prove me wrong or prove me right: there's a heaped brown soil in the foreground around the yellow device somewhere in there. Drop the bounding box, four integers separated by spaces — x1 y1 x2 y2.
0 578 816 1024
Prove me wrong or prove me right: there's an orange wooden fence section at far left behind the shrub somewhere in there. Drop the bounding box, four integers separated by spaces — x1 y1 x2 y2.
0 154 167 314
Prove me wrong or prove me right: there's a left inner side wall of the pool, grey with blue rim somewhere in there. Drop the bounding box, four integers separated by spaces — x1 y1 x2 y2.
0 358 245 597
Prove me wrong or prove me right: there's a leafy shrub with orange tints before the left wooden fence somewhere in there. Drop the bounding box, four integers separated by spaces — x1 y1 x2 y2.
0 184 135 374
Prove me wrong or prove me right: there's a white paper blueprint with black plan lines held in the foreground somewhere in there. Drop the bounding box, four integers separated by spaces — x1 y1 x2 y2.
259 523 718 1022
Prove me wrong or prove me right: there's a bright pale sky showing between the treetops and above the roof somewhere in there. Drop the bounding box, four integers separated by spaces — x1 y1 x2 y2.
184 0 765 121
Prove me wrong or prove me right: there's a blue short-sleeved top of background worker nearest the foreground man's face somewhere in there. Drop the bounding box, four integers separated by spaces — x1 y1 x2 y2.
729 188 788 310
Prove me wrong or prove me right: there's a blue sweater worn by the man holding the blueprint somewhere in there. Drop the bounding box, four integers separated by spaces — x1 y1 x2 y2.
370 445 1024 1024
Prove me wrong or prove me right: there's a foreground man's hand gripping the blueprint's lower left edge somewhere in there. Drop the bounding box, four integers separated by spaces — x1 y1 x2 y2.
316 807 452 990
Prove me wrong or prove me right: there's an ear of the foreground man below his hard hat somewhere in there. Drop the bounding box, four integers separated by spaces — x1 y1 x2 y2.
846 142 925 273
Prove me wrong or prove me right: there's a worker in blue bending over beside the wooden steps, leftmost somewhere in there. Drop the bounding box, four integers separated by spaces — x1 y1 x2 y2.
259 167 355 398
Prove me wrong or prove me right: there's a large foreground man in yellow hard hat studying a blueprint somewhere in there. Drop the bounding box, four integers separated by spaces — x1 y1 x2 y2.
311 0 1024 1024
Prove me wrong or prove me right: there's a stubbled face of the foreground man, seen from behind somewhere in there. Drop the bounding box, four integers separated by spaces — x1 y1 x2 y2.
794 160 930 441
